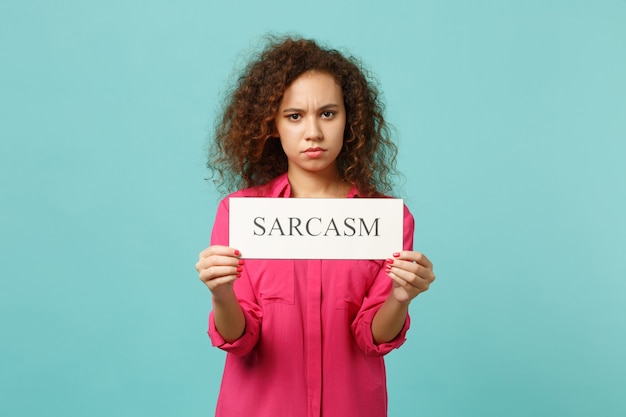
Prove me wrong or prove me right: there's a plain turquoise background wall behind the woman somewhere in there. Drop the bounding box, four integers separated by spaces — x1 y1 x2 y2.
0 0 626 417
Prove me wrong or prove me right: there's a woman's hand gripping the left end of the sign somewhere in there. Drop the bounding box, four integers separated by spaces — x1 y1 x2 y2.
196 245 244 299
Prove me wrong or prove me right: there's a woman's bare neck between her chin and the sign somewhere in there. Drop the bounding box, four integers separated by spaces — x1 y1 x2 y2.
287 170 350 198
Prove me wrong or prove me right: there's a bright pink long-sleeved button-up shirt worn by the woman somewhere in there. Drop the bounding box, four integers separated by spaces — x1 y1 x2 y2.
208 174 414 417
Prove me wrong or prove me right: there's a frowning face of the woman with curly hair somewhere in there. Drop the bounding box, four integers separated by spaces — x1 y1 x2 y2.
275 71 346 179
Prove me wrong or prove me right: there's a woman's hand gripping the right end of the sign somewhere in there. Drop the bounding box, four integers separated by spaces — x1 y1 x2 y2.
385 251 435 304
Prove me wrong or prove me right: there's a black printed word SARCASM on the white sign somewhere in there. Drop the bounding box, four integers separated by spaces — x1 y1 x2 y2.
254 217 380 237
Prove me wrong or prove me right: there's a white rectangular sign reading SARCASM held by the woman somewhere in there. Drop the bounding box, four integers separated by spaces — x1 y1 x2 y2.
229 197 404 259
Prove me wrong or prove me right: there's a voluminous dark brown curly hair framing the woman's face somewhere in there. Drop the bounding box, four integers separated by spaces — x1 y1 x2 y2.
208 37 397 197
